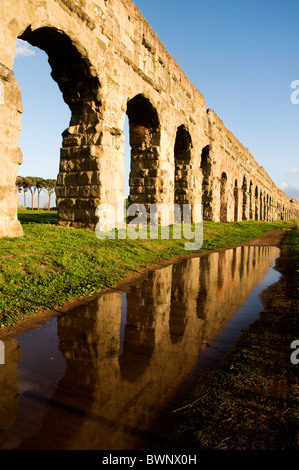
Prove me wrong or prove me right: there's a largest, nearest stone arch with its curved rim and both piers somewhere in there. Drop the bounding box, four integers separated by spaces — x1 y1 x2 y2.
0 2 109 236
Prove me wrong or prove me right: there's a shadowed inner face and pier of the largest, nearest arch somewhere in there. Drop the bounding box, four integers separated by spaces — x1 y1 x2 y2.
19 27 102 228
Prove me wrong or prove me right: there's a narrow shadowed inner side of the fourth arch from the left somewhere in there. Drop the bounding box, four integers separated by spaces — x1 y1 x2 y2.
200 145 213 220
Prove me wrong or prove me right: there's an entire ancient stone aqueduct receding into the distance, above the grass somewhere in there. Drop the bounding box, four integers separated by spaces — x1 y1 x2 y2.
0 0 299 237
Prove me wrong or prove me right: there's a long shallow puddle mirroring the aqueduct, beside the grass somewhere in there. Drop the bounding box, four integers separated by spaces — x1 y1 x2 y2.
0 246 280 450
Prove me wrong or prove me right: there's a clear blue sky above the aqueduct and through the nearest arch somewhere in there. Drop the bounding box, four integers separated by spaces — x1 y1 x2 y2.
14 0 299 199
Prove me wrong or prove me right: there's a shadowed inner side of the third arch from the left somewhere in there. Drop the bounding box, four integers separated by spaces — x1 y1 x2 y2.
174 125 192 209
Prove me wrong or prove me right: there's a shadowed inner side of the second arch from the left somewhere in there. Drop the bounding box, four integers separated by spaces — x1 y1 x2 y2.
127 94 161 204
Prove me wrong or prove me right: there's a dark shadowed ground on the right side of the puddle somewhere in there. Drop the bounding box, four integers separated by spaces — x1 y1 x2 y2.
172 224 299 451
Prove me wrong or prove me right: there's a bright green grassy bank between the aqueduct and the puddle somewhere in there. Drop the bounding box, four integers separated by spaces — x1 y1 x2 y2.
0 211 296 327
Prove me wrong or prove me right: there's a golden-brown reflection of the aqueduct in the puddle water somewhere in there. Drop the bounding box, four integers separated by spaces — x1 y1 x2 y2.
0 247 279 449
